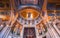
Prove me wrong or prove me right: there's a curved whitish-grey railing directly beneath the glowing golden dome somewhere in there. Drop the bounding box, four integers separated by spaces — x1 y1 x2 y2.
17 17 41 25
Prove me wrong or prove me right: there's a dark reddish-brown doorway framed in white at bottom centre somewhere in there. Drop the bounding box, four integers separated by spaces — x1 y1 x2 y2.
23 27 36 38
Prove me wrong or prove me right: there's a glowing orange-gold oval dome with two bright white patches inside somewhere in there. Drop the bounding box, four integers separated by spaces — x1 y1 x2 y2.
20 8 39 19
